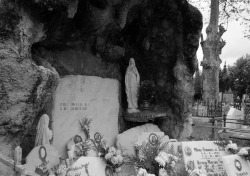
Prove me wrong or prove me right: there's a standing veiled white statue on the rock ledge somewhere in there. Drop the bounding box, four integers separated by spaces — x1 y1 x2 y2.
125 58 140 113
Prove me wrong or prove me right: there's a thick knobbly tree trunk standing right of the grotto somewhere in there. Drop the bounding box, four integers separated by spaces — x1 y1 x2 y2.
201 0 226 100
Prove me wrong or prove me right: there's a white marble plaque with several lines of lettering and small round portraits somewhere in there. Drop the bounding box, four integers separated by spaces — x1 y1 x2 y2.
181 141 227 176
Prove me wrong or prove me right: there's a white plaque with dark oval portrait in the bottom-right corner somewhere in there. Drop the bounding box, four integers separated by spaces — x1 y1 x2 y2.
222 155 250 176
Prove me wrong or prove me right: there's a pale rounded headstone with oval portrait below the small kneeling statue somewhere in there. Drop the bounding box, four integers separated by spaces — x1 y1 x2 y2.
24 145 60 171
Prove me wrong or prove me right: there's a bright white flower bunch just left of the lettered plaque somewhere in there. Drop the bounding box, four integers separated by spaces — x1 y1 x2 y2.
155 151 178 173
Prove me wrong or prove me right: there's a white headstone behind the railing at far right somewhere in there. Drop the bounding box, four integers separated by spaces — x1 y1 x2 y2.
226 107 244 129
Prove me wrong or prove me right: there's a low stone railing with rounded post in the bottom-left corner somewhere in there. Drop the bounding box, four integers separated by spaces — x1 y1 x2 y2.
0 146 39 176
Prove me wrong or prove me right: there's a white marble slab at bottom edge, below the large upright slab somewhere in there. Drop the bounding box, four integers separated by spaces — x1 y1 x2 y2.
68 157 107 176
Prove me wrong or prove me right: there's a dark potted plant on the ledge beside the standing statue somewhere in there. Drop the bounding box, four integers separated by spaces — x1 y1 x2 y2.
139 80 156 109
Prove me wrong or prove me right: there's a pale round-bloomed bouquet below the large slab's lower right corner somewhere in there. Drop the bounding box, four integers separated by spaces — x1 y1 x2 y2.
104 147 123 172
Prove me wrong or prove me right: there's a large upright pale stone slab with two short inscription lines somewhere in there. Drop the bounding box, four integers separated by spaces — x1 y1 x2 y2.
52 75 120 157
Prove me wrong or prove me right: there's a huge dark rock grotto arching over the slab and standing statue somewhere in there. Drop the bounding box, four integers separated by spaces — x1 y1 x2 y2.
0 0 202 170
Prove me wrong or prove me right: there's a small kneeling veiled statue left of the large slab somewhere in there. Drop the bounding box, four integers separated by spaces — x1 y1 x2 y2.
35 114 53 147
